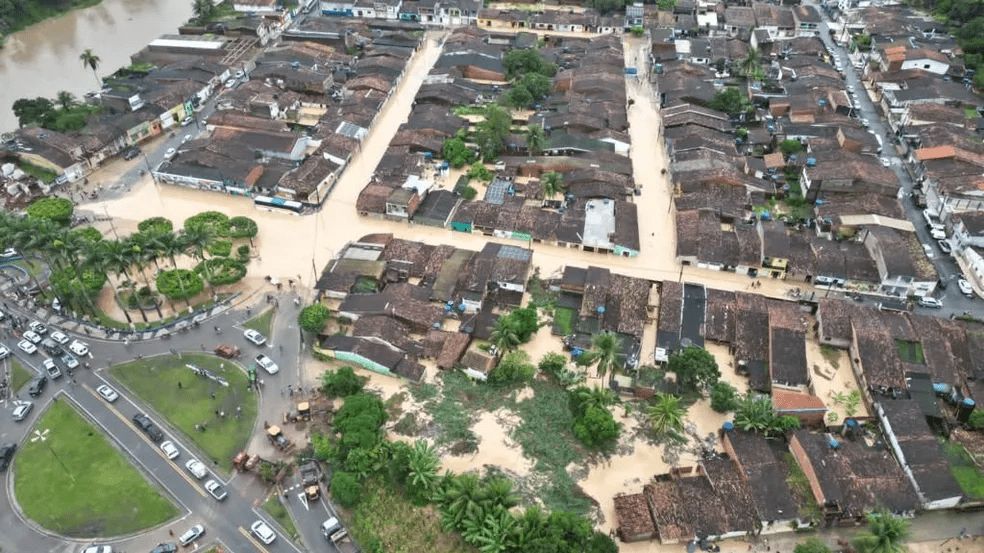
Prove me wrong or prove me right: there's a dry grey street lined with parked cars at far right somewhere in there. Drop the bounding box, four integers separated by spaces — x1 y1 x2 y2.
814 4 984 316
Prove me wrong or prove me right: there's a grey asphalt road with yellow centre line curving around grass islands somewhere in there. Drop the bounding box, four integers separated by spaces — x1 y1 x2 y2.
0 291 335 553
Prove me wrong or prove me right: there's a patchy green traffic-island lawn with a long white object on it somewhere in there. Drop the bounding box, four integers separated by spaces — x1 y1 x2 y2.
110 353 257 472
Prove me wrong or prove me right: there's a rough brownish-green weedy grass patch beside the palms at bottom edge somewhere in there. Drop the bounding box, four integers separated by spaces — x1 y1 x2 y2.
343 479 477 553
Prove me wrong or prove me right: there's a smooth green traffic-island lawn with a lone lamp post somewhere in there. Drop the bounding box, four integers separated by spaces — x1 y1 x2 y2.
13 401 178 538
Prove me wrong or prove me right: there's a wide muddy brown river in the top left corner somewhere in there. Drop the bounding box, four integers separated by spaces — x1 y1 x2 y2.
0 0 191 132
